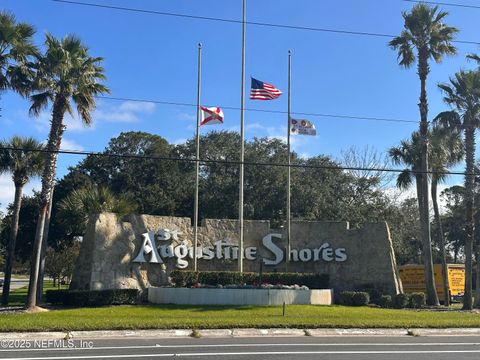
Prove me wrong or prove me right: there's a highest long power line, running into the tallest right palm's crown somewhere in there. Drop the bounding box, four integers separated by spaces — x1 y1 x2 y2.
51 0 480 45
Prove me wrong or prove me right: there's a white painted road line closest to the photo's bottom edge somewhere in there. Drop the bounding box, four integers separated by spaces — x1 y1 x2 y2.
9 350 480 360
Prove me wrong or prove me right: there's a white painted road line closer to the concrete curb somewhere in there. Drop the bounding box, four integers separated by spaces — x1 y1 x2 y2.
0 343 480 352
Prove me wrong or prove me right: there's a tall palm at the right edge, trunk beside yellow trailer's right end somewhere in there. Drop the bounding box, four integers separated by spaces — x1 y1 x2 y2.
434 71 480 310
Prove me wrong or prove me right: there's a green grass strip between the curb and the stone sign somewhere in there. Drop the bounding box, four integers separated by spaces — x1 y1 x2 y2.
0 305 480 331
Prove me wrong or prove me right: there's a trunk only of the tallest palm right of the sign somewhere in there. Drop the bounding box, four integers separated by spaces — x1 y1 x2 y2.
418 49 440 305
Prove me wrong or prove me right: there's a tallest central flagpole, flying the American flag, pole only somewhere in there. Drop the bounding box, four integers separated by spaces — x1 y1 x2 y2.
238 0 246 272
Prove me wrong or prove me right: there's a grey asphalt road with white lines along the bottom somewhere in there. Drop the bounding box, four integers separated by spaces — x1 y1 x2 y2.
0 336 480 360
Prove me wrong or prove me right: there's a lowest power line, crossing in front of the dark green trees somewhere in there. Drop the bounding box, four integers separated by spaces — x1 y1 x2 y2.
0 146 472 176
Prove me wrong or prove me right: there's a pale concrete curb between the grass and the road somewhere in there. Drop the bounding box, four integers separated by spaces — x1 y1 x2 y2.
0 328 480 340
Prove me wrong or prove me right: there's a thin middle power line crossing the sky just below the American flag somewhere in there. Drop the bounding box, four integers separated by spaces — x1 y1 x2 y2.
97 96 418 124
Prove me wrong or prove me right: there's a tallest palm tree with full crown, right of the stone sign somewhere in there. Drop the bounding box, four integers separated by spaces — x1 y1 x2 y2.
389 3 458 305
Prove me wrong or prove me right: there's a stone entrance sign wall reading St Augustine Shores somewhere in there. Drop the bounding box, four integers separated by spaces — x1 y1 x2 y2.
71 214 401 293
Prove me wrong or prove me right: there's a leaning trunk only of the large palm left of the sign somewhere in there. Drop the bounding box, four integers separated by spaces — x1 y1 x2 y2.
26 94 67 309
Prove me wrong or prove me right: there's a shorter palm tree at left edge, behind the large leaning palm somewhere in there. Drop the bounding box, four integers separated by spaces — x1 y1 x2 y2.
0 136 44 305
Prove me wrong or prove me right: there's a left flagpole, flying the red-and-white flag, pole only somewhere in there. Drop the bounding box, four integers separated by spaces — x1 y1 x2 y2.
193 43 202 271
